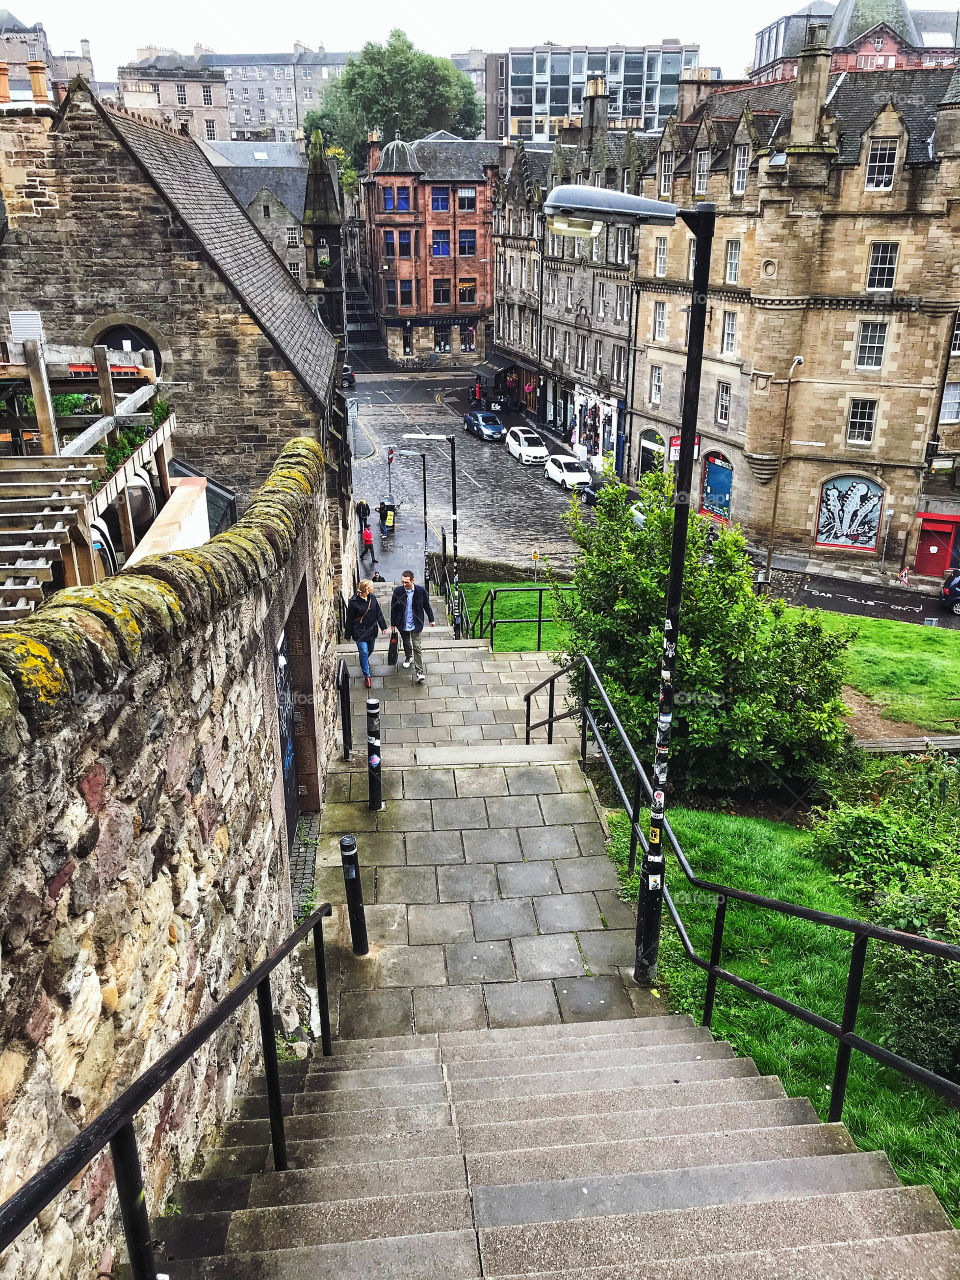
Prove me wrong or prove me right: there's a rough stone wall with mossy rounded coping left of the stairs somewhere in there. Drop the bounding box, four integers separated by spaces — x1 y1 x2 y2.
0 439 335 1280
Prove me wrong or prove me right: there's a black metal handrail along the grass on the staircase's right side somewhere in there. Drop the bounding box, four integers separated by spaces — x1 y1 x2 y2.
524 657 960 1123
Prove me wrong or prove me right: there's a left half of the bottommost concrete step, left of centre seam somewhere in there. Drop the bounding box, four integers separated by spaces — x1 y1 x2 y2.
166 1230 480 1280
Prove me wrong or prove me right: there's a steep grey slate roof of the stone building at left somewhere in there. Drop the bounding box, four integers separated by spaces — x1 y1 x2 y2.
99 105 337 403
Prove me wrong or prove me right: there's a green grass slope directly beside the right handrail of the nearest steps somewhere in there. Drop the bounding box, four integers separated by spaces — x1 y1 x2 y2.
609 808 960 1225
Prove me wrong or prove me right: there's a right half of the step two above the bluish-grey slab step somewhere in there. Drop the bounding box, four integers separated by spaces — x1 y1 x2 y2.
460 1098 818 1155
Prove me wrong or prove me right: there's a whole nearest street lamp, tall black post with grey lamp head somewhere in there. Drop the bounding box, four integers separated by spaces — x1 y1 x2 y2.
544 186 717 986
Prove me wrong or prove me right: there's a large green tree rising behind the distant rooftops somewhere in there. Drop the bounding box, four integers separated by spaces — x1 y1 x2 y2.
308 31 483 169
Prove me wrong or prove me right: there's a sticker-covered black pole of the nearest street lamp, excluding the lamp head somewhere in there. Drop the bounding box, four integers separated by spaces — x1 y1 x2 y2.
634 204 717 986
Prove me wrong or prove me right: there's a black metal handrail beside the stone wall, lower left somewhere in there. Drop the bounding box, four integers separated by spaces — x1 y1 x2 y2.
0 902 333 1280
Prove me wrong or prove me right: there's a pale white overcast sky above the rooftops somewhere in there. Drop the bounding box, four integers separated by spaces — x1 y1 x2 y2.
26 0 803 79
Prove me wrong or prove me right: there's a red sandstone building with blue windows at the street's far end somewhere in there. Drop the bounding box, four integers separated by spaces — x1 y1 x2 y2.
364 131 499 366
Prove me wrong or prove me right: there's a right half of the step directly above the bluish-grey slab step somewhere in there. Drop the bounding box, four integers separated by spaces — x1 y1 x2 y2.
467 1124 856 1187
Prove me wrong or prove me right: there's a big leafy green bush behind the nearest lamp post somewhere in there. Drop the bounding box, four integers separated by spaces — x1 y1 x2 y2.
554 472 849 794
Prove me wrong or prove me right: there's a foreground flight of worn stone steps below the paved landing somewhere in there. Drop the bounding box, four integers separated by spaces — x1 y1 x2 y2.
156 1016 960 1280
